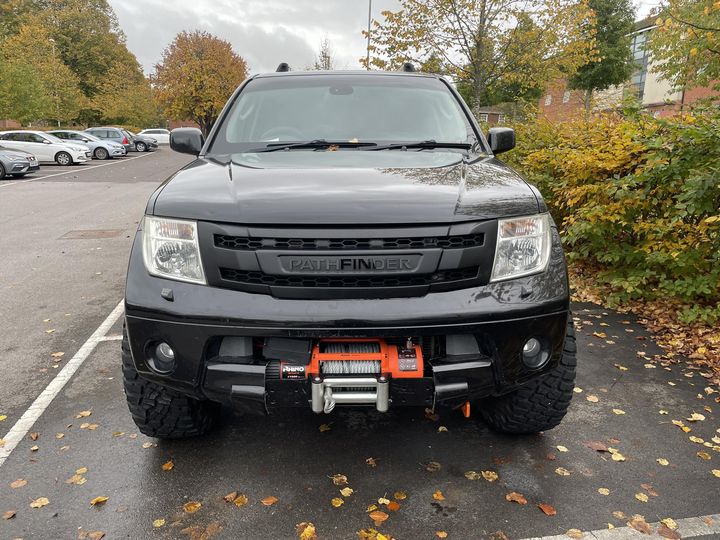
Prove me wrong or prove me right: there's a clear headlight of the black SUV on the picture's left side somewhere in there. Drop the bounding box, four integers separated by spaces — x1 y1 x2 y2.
143 216 205 285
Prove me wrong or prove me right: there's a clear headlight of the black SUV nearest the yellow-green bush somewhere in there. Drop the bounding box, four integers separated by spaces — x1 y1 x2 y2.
490 214 550 281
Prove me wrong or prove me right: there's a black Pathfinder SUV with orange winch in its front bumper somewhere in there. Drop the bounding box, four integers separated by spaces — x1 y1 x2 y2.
122 66 575 438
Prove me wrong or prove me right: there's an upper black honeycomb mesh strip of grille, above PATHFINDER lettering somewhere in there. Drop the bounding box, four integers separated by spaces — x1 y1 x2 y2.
214 233 485 251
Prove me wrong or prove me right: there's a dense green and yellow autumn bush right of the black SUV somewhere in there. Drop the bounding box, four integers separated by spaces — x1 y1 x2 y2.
508 107 720 322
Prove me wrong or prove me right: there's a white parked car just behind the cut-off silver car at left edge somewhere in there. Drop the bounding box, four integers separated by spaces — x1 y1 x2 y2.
0 130 92 165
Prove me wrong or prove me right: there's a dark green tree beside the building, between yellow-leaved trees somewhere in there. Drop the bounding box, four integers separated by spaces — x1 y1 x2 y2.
568 0 636 114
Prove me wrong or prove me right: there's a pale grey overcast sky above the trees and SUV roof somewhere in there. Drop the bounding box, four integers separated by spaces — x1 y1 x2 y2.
109 0 655 74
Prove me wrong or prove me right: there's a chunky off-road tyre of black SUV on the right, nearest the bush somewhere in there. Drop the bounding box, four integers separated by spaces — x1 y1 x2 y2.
479 317 577 434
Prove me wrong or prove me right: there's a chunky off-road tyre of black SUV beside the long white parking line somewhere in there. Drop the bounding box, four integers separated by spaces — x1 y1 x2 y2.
122 329 218 439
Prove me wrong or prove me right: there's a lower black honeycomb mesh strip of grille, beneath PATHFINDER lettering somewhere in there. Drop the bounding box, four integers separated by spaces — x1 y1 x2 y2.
220 266 479 288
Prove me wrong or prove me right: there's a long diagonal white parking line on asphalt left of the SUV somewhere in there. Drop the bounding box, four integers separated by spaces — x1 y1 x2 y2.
0 301 123 467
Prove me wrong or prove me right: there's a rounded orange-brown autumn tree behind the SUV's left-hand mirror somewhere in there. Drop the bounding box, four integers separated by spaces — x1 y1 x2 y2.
152 31 247 135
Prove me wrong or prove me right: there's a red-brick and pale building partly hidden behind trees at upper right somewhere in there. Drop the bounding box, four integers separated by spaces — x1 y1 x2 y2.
538 18 720 121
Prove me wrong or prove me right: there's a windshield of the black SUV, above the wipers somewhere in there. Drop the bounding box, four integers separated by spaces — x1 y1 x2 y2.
208 75 476 154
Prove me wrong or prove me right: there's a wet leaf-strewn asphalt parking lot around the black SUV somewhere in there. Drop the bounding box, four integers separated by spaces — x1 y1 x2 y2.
0 149 720 539
